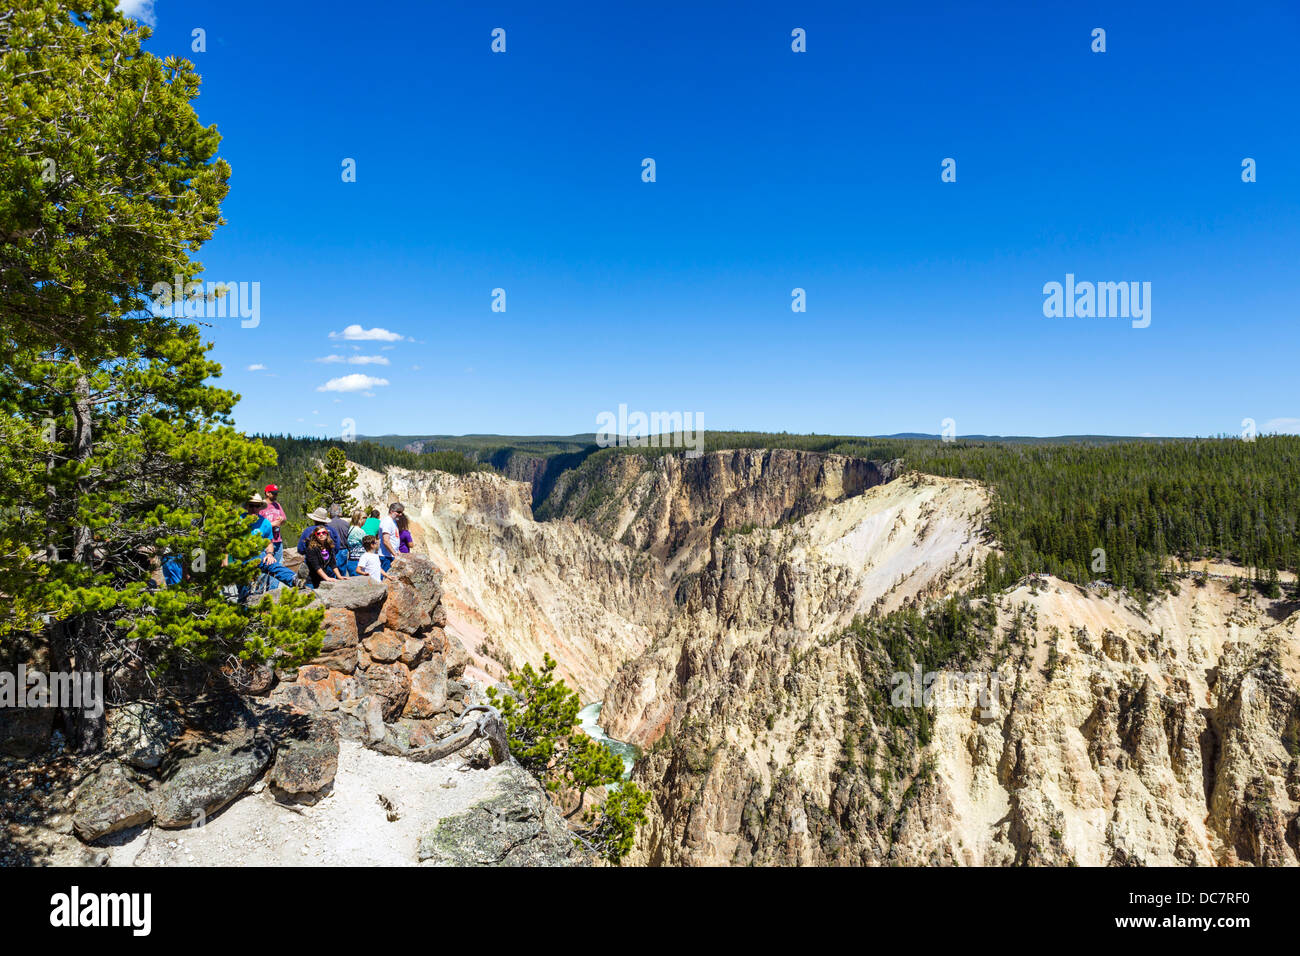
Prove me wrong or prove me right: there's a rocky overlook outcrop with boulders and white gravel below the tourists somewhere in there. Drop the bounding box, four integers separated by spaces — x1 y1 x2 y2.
0 555 590 866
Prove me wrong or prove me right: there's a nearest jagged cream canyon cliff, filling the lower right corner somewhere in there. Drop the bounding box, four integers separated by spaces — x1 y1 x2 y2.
611 579 1300 865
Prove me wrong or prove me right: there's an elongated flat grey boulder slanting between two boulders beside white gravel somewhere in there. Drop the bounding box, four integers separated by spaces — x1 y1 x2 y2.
151 734 276 829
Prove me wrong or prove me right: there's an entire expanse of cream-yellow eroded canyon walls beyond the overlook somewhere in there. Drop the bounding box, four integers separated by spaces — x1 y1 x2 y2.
359 450 1300 865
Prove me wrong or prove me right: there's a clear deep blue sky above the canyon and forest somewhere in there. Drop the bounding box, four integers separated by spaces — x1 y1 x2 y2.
116 0 1300 434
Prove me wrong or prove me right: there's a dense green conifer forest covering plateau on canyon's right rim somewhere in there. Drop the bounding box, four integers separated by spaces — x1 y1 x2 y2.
512 432 1300 592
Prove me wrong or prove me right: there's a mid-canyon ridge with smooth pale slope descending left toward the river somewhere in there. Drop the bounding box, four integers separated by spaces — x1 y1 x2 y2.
601 475 988 747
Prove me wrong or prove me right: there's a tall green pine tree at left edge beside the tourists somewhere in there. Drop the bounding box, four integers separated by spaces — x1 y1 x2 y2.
0 0 321 749
